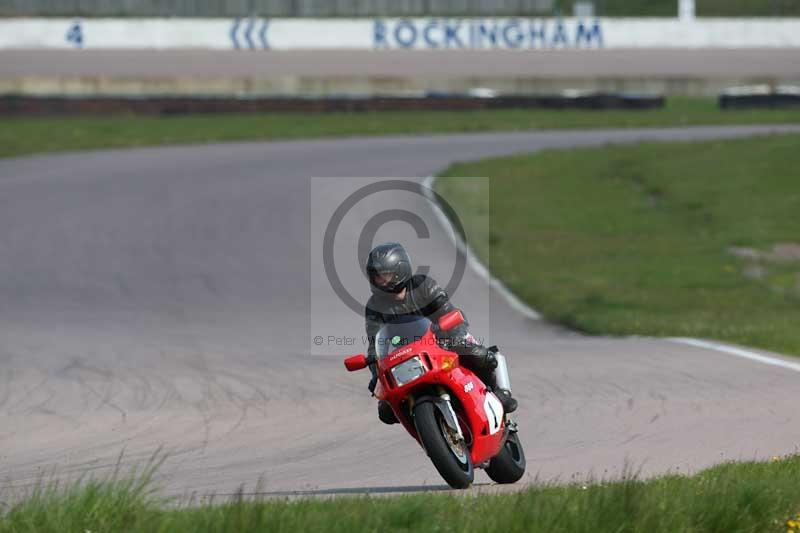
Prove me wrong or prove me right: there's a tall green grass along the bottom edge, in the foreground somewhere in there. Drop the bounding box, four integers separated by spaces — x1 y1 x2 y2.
0 457 800 533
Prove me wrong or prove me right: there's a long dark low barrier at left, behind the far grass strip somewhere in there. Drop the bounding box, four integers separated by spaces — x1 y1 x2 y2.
0 93 665 116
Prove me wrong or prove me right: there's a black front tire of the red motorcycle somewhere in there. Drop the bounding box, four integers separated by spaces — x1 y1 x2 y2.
414 402 475 489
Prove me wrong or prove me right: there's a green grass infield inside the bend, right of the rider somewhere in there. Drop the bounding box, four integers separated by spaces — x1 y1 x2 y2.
437 135 800 355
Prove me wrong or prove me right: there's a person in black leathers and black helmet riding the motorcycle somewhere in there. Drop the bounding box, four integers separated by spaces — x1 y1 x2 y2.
364 242 517 424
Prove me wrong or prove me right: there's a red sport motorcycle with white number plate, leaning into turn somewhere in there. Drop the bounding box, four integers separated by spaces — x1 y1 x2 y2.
344 310 525 489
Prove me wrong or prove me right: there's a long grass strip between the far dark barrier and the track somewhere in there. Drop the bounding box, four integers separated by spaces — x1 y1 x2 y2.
0 98 800 157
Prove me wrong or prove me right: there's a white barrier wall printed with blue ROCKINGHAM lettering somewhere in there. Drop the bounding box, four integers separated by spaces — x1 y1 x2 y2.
0 18 800 50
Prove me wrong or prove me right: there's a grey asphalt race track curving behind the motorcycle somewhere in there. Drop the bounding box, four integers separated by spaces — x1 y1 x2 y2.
0 126 800 494
